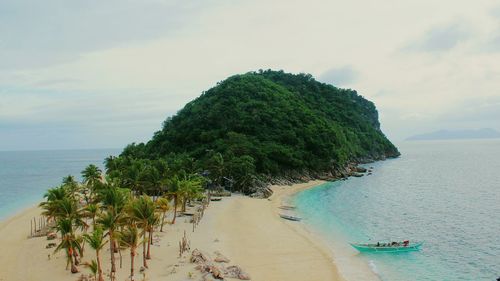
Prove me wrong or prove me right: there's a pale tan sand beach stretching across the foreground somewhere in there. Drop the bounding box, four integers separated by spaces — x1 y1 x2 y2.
0 181 368 281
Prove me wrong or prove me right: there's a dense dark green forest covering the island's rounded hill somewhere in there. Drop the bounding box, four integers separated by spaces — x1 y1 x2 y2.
111 70 399 192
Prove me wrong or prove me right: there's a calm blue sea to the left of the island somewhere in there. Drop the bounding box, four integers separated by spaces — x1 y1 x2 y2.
0 149 120 219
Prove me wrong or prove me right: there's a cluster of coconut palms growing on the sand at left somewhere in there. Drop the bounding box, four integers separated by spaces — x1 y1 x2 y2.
40 163 205 281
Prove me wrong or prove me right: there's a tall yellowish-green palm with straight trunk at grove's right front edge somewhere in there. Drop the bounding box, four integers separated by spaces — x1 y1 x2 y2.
129 195 156 268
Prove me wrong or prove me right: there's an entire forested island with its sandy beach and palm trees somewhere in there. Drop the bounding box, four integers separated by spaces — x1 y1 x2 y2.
0 70 400 281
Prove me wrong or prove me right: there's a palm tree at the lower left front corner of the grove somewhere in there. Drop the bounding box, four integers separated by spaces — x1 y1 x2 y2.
54 218 82 273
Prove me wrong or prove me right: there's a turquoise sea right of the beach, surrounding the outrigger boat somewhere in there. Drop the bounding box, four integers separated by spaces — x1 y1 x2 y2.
293 140 500 281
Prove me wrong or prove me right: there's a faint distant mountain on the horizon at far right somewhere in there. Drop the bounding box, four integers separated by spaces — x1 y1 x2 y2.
406 128 500 140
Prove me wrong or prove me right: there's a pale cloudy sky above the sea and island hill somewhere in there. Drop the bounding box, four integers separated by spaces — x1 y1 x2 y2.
0 0 500 150
